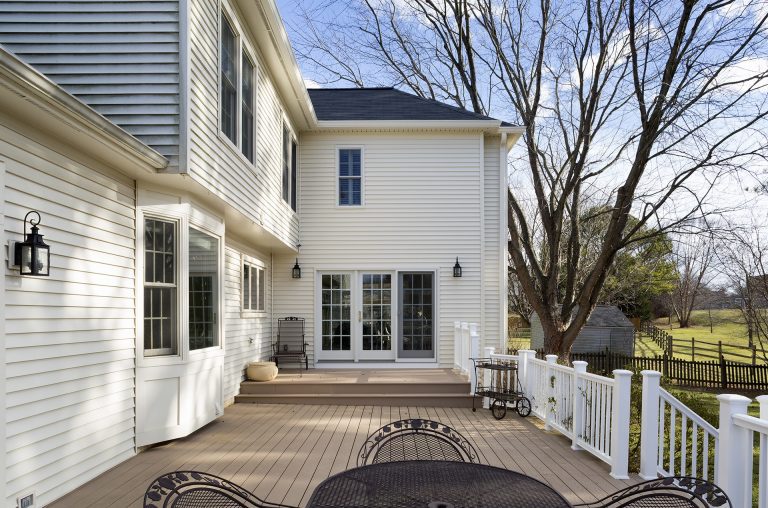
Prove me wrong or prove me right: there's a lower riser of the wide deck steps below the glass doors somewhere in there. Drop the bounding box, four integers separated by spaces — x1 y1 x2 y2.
235 390 472 408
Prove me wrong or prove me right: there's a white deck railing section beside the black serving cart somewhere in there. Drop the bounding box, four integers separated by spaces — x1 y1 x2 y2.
486 348 632 479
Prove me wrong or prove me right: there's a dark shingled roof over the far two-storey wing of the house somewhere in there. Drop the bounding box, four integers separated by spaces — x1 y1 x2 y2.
307 88 510 125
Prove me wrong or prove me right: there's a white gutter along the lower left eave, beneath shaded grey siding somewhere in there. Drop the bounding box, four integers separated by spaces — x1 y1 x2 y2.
0 45 168 173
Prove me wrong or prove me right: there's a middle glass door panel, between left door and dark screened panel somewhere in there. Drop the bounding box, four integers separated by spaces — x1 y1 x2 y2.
360 273 394 360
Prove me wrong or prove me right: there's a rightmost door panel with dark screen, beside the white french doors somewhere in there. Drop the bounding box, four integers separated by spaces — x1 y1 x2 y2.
397 272 435 358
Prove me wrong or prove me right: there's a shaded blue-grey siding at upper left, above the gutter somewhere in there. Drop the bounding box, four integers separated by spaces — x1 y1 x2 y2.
0 0 180 169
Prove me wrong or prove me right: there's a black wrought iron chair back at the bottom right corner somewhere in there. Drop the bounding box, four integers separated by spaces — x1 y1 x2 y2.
576 476 732 508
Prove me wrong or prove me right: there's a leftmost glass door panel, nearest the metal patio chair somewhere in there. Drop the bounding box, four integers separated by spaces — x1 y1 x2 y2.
320 273 352 359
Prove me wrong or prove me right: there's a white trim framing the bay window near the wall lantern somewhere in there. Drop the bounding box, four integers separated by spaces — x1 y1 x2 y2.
135 192 225 367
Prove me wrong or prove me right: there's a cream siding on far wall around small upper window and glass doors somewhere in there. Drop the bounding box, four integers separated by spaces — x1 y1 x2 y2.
274 132 498 366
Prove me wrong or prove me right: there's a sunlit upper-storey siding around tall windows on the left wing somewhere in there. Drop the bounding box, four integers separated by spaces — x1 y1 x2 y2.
189 0 298 247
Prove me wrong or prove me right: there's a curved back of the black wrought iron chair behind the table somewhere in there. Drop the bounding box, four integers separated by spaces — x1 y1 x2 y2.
357 418 478 466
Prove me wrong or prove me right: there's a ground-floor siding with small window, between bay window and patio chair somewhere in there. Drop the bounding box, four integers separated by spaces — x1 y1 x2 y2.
224 239 272 405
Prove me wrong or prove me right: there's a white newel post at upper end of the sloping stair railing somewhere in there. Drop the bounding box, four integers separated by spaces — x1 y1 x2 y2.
640 370 661 480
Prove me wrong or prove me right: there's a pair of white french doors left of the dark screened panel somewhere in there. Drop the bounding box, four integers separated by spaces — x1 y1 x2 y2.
317 271 395 361
